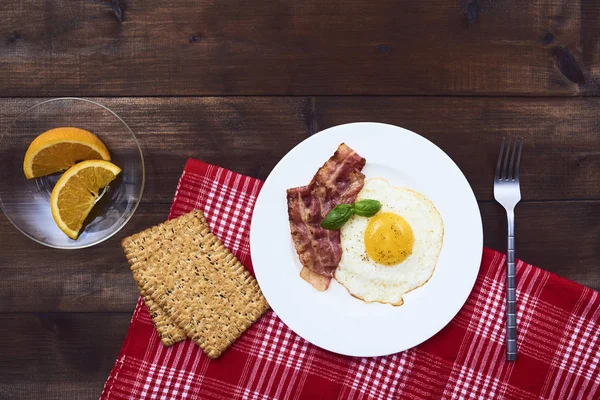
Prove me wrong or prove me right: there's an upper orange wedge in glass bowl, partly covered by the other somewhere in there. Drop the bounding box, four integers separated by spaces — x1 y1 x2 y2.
23 127 110 179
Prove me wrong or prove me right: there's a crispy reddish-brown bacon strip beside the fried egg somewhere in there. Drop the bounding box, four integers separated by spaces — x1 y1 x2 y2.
287 143 366 291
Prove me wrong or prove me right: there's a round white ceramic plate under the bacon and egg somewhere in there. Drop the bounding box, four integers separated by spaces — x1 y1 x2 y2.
250 122 483 357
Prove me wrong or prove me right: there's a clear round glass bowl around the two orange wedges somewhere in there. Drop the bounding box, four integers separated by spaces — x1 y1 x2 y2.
0 98 145 249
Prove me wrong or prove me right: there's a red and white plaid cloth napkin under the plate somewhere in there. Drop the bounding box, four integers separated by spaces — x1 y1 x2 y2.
100 160 600 400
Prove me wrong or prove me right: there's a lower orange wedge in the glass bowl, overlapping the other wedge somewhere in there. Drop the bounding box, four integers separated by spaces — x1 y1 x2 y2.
50 160 121 239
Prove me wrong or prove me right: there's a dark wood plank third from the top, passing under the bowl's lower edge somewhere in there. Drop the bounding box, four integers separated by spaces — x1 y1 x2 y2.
0 201 600 312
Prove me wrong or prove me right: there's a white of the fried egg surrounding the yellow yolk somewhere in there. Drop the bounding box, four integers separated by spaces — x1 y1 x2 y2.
335 178 444 306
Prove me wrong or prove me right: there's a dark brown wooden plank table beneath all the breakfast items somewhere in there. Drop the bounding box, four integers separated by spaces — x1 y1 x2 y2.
0 0 600 399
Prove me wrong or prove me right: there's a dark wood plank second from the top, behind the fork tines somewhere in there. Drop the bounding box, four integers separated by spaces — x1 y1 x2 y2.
0 97 600 203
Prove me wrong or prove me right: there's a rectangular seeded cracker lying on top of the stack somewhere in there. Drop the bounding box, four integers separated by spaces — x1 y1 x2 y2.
123 210 269 358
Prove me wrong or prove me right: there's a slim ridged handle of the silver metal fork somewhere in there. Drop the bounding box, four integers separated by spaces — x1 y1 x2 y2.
506 210 517 361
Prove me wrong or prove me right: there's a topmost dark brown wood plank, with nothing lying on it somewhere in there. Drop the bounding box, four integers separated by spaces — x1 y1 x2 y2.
0 0 600 96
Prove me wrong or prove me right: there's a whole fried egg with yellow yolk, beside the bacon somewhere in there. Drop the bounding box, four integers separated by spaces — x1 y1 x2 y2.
335 178 444 306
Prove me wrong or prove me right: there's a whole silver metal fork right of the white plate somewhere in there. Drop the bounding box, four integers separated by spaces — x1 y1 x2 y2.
494 138 523 361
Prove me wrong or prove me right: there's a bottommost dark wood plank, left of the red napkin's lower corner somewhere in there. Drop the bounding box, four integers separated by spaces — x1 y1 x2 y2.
0 313 131 400
